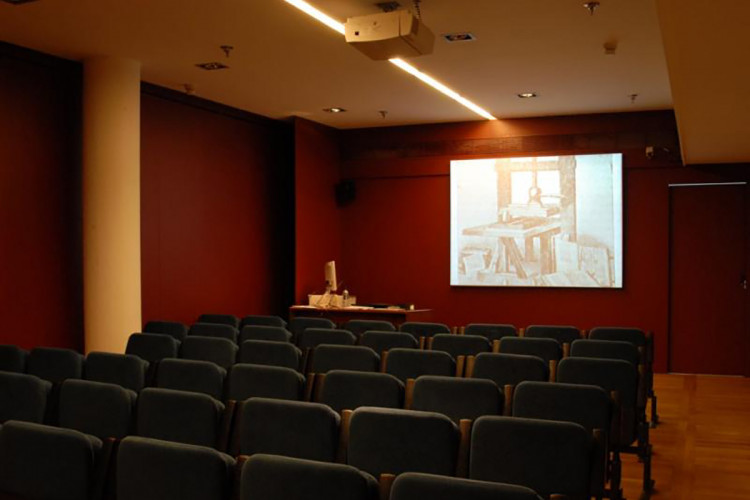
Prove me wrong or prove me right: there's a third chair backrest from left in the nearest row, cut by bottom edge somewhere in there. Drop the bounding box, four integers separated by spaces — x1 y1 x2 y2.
244 453 378 500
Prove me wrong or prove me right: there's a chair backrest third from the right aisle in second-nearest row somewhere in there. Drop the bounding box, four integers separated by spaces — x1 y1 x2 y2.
235 398 340 462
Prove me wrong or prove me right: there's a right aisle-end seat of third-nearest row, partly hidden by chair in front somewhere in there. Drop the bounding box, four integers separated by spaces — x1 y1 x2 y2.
513 381 622 500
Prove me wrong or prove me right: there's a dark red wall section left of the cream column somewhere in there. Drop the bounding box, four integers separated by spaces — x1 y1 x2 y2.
0 44 83 349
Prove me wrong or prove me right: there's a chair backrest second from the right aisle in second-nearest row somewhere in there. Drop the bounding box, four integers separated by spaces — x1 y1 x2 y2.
348 406 459 477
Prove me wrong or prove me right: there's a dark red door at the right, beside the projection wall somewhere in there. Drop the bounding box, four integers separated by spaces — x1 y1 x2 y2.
668 183 750 376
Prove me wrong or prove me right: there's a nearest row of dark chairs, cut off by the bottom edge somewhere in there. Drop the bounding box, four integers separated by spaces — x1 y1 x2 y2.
0 421 540 500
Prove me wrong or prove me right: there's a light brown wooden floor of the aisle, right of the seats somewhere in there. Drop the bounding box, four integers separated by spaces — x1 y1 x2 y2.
623 374 750 500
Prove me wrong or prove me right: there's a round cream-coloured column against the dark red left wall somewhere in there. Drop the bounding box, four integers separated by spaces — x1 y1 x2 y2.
83 57 141 353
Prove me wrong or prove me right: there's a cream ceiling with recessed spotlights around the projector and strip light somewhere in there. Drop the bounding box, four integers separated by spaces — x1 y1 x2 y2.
0 0 750 161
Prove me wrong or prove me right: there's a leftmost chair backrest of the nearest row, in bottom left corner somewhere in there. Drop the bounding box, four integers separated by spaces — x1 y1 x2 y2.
0 421 102 500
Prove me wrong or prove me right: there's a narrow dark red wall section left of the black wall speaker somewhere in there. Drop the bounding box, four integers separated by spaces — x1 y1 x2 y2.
294 118 348 304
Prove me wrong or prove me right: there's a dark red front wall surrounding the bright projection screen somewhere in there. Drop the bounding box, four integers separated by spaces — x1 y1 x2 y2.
339 112 750 370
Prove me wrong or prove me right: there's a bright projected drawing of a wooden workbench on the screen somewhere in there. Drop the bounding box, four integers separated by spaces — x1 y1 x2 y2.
450 154 623 288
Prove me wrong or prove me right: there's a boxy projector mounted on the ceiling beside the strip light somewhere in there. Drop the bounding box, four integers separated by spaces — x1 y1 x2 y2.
344 10 435 61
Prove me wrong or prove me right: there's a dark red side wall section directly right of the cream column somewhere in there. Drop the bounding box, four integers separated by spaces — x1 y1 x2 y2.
141 87 292 323
